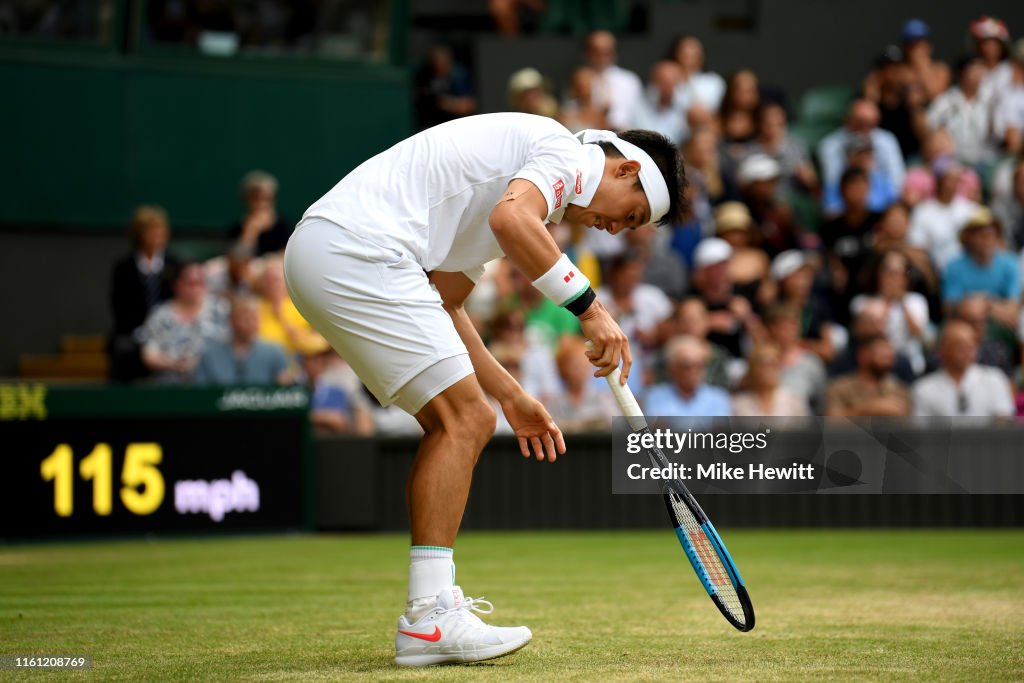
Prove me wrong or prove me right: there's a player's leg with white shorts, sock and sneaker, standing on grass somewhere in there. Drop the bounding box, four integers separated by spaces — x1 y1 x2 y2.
285 220 531 666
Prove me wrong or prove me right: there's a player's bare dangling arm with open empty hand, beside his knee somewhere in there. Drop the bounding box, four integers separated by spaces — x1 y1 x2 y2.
429 270 565 462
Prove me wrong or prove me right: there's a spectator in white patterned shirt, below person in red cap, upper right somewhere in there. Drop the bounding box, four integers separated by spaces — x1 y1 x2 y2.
927 57 996 167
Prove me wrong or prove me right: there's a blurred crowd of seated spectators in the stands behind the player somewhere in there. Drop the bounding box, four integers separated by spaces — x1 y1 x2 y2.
111 16 1024 433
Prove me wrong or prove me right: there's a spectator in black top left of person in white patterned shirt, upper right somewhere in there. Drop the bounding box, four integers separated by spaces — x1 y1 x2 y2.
863 45 929 159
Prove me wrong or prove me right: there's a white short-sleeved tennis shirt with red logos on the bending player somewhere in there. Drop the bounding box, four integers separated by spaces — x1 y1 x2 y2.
303 114 604 282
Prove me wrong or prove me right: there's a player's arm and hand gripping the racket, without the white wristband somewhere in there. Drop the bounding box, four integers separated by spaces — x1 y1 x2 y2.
490 178 633 384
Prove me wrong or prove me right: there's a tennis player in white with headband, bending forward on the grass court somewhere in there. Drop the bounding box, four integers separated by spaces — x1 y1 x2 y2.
285 114 684 666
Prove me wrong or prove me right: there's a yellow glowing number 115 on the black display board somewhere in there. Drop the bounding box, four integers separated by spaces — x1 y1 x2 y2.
39 443 165 517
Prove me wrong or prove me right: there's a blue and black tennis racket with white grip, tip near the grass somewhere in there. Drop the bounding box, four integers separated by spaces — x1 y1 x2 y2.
606 368 754 632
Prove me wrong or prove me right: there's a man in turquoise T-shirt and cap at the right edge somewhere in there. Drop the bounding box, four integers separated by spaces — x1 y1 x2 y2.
942 207 1021 330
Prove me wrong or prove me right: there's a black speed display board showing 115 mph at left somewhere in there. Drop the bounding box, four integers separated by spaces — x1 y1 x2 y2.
0 385 308 538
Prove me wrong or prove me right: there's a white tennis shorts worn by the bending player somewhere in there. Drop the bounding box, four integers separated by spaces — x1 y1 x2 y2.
285 218 473 415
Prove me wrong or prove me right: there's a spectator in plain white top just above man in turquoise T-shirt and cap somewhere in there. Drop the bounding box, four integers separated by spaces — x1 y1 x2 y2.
907 158 978 270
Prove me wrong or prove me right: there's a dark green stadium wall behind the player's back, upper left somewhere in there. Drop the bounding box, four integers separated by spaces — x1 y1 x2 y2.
0 51 412 236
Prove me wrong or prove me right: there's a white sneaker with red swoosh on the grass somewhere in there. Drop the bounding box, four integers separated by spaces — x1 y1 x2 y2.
394 586 534 667
